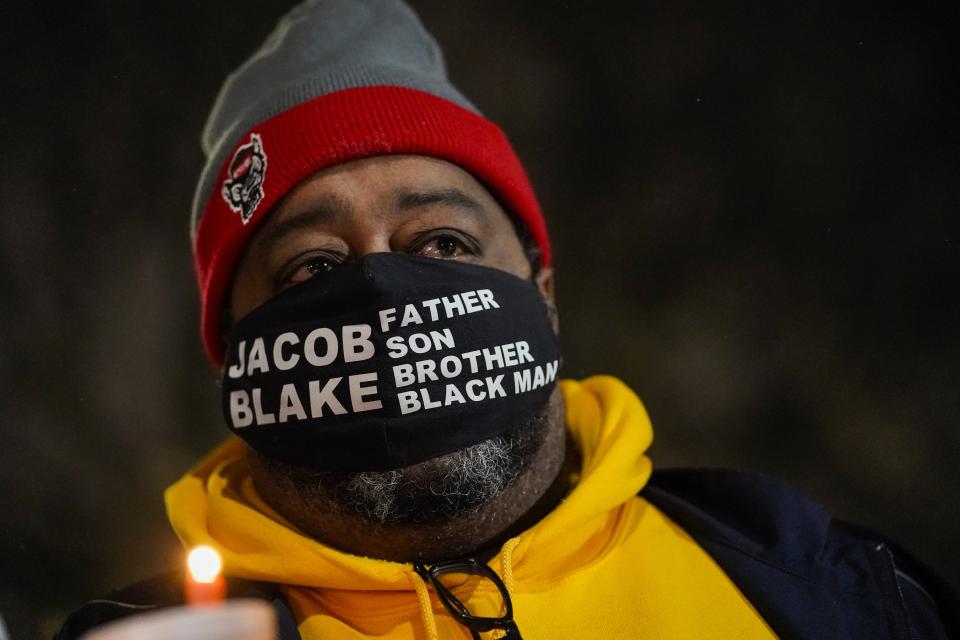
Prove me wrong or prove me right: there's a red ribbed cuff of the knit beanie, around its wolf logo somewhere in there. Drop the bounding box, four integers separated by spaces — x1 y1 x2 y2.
194 86 550 366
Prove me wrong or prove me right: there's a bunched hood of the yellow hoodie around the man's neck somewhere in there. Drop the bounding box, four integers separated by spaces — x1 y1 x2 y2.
165 376 653 592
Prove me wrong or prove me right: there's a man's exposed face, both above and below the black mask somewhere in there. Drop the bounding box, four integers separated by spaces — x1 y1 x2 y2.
229 155 563 544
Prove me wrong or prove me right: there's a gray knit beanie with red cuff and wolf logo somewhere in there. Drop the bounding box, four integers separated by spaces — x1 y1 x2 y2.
191 0 550 365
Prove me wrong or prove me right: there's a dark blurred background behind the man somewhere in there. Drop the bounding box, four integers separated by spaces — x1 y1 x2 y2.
0 0 960 639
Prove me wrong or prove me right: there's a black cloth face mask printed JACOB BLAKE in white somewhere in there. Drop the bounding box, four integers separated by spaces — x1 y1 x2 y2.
223 253 560 471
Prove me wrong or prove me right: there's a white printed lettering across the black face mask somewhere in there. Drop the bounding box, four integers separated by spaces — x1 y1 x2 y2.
226 289 559 429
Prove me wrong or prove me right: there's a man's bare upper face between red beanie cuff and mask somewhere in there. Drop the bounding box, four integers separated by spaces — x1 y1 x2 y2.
230 155 553 319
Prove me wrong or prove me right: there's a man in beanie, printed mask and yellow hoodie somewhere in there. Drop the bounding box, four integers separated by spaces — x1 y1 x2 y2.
60 0 956 639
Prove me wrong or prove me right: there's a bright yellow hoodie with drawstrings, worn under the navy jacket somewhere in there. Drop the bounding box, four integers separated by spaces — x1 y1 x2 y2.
166 376 776 640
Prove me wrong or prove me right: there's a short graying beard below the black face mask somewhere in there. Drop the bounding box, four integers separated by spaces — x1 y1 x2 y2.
311 405 550 526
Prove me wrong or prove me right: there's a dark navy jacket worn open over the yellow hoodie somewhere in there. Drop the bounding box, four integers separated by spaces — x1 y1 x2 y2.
55 469 960 640
